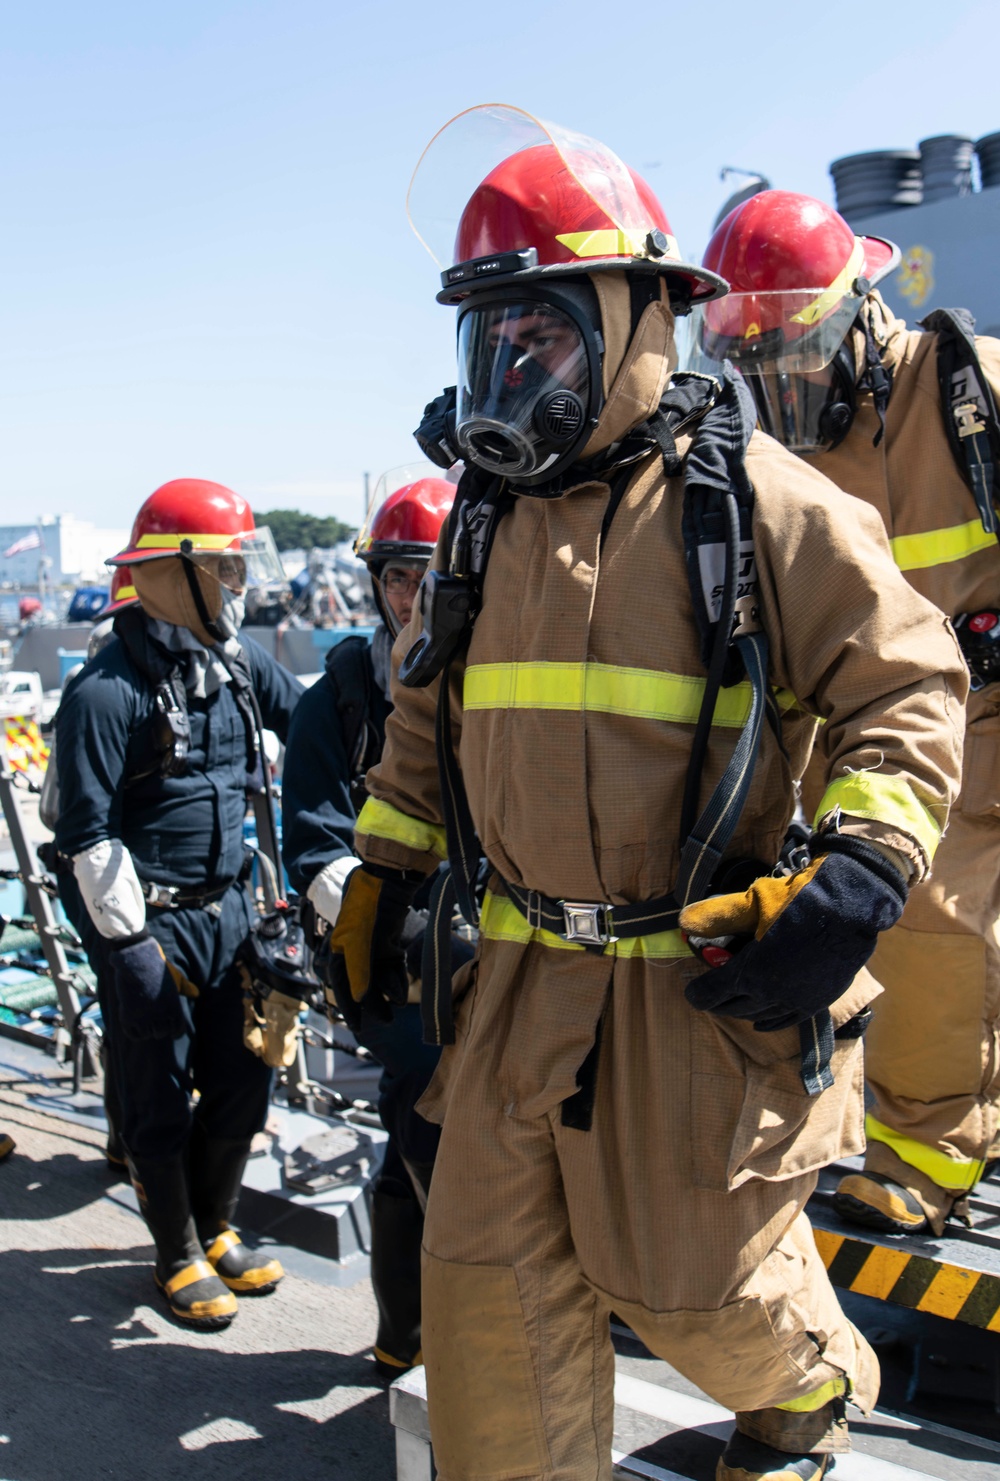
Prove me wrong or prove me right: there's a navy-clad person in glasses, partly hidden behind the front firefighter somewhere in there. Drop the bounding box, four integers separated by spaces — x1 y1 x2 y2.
281 467 468 1377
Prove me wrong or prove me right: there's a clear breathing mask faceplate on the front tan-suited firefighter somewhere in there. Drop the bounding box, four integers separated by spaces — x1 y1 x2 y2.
455 293 603 486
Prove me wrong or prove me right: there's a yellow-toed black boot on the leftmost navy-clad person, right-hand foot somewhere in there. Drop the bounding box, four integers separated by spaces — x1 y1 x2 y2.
191 1124 284 1296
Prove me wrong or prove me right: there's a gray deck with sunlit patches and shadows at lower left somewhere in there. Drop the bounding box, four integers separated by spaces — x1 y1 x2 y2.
0 1040 396 1481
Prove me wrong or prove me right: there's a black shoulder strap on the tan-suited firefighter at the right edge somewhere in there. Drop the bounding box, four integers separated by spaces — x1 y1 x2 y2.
919 308 1000 535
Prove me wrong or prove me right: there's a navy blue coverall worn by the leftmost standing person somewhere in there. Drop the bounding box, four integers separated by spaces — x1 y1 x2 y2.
56 624 302 1160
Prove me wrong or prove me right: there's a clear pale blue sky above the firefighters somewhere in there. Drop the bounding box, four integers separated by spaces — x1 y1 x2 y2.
0 0 1000 526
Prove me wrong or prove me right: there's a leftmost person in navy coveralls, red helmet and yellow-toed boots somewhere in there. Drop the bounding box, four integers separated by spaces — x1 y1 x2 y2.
55 478 302 1330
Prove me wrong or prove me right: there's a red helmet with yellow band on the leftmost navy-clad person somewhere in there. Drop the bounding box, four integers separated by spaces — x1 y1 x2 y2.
107 478 255 566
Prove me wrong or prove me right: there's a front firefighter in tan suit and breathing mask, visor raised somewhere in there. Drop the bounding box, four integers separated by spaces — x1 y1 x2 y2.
330 105 964 1481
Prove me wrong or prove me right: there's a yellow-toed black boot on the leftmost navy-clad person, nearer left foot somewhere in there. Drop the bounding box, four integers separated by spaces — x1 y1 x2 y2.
129 1154 237 1331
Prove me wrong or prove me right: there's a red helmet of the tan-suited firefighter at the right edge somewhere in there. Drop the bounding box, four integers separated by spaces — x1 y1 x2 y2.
704 190 899 372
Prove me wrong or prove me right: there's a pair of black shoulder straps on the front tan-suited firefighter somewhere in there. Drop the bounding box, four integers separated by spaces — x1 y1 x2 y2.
414 364 779 947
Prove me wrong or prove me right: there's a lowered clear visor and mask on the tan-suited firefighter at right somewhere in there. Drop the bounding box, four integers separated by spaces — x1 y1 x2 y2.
679 289 864 453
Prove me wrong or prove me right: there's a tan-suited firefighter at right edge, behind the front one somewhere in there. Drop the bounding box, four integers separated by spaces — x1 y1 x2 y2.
699 191 1000 1235
